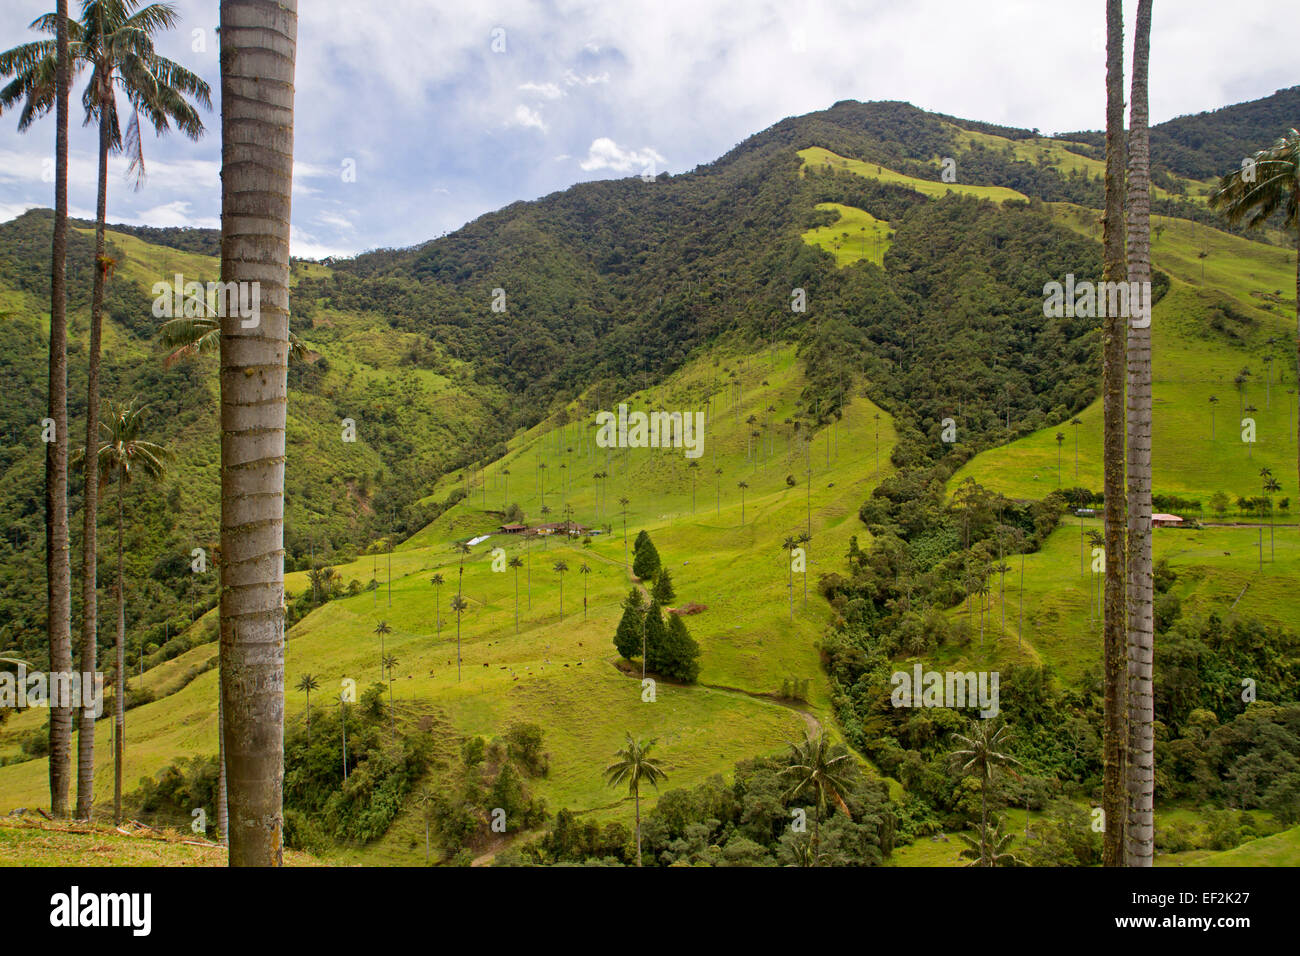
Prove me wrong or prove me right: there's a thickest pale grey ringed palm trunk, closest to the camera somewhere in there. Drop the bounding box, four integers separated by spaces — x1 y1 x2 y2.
221 0 298 866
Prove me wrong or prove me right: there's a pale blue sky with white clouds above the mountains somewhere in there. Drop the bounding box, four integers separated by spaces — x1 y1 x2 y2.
0 0 1297 256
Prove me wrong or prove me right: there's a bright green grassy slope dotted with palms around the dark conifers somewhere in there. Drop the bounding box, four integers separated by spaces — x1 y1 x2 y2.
0 340 893 862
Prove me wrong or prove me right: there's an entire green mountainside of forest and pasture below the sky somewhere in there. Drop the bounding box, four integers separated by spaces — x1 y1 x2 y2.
0 89 1300 865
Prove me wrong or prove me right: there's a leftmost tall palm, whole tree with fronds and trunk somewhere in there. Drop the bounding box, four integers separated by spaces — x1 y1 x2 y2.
0 0 74 819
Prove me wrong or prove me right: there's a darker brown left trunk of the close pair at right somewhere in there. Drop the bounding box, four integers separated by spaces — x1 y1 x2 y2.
1101 0 1128 866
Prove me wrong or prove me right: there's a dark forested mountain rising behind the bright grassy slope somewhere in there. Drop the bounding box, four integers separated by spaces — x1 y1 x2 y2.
0 91 1279 681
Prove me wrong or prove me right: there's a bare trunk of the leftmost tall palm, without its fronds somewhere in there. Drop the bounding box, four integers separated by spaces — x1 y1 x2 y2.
46 0 73 818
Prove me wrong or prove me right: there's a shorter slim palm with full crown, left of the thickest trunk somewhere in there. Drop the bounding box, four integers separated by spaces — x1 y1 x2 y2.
78 402 168 823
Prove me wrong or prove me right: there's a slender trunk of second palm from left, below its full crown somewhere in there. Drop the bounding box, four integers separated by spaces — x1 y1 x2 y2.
77 88 112 819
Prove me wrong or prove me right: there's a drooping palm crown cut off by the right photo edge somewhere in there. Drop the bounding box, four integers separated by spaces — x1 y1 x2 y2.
1209 129 1300 502
